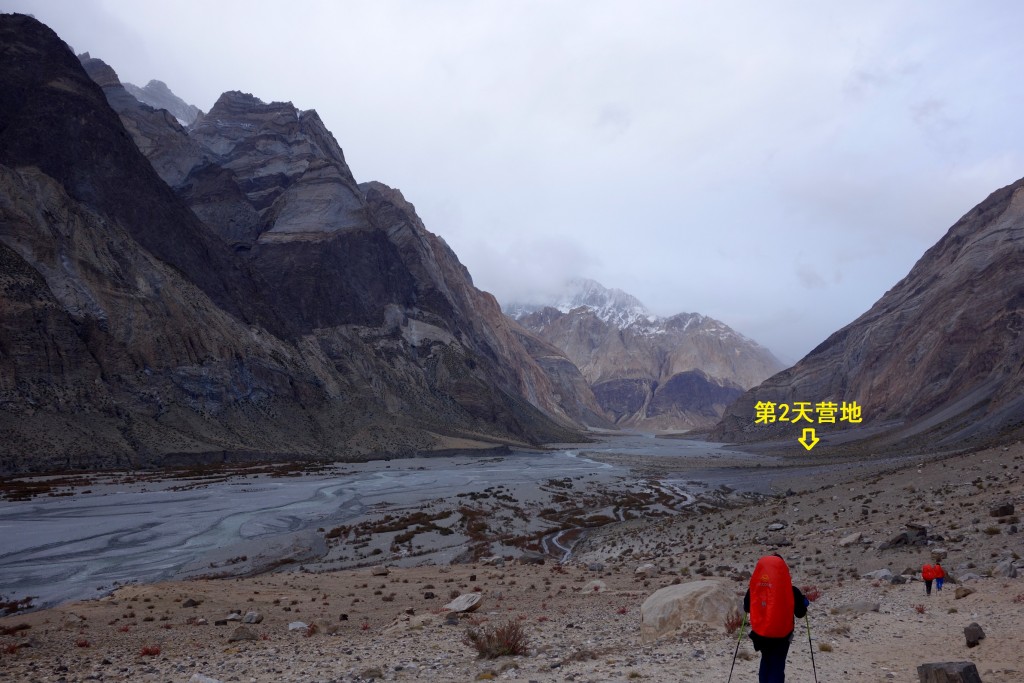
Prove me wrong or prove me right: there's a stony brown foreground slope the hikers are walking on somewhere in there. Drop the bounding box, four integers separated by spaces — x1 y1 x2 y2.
0 443 1024 683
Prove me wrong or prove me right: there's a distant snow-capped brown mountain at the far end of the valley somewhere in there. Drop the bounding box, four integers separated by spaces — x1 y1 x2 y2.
507 281 781 429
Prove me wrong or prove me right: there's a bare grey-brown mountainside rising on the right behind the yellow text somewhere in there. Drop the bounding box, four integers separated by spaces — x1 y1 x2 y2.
715 180 1024 446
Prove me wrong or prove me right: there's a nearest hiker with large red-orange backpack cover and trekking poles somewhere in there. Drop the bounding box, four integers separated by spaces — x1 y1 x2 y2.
743 555 810 683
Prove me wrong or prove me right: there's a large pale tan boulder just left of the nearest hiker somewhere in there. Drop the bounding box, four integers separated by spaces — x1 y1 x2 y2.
640 580 740 642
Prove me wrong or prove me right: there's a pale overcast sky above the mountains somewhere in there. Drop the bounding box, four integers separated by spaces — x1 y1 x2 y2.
8 0 1024 361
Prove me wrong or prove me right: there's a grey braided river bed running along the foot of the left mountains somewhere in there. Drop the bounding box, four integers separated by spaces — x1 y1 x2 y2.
0 435 764 607
